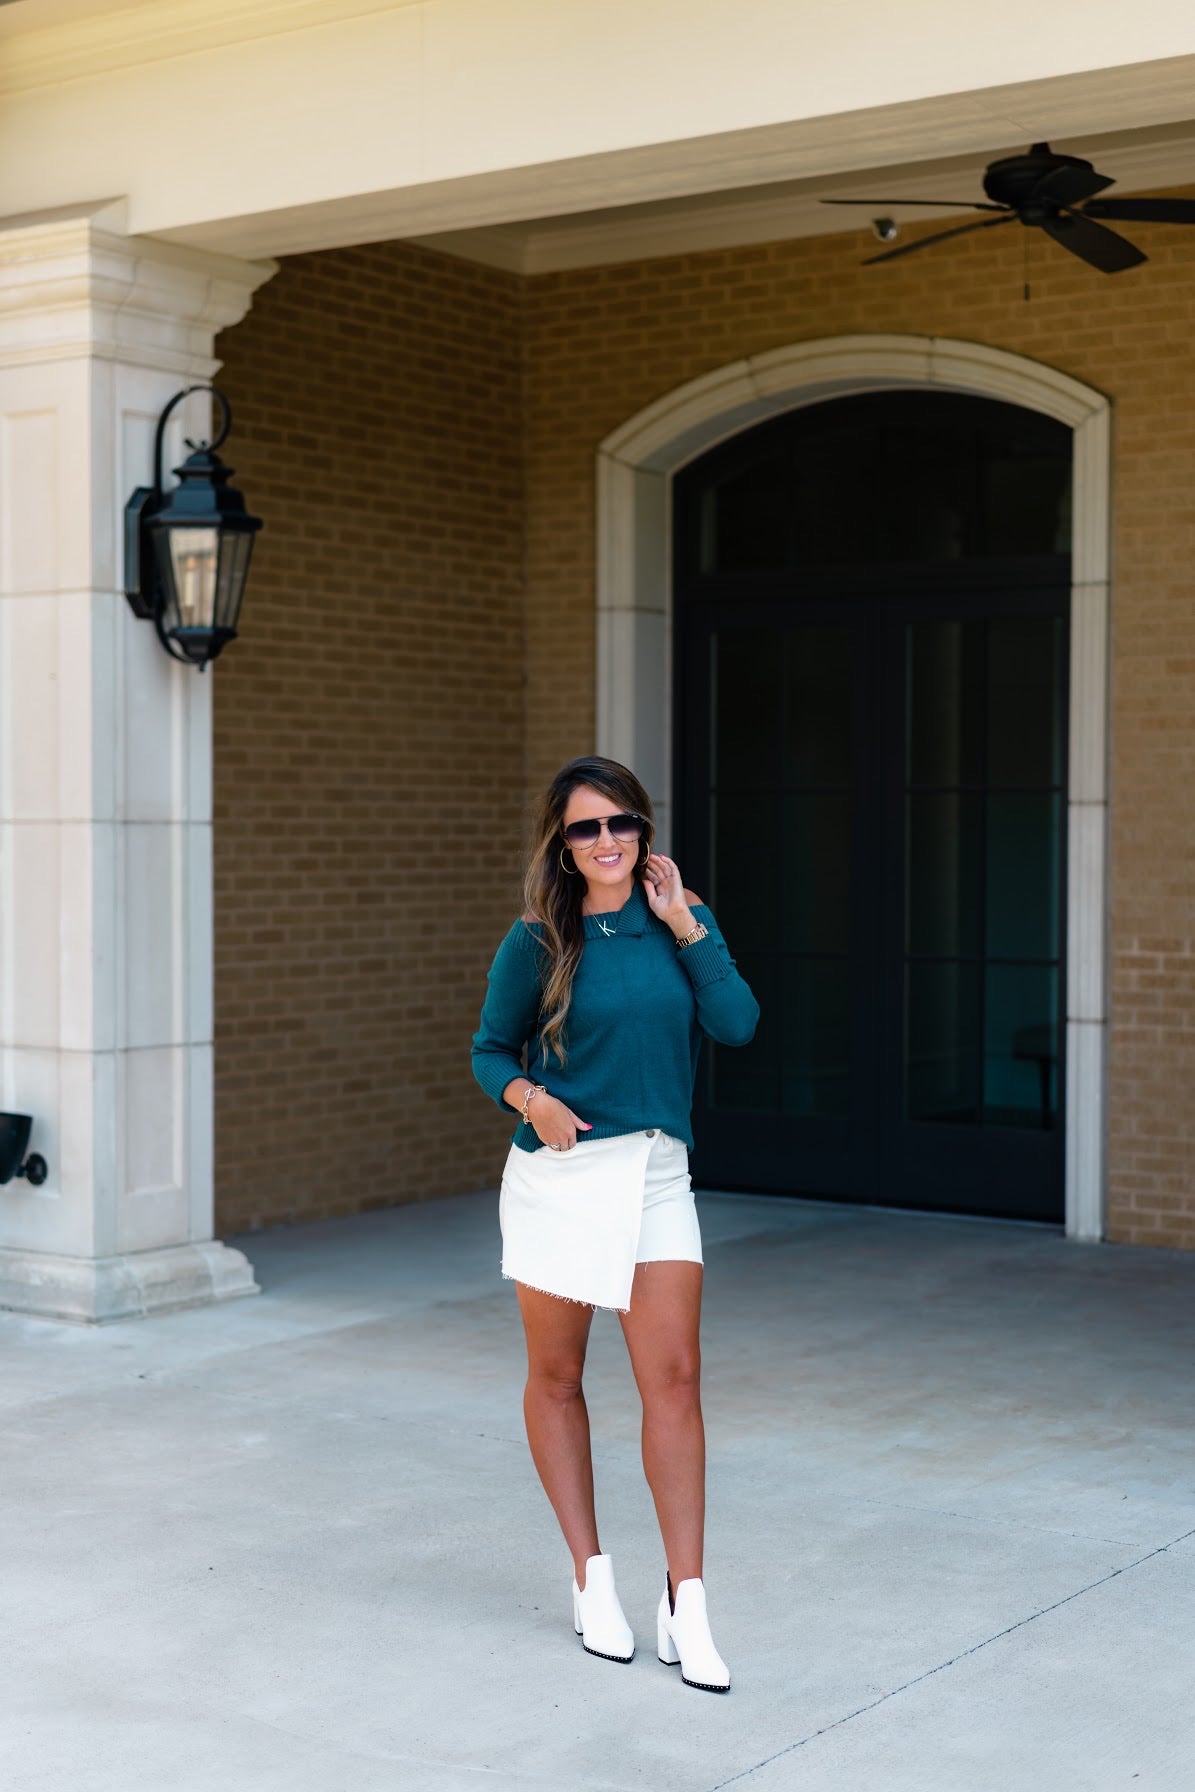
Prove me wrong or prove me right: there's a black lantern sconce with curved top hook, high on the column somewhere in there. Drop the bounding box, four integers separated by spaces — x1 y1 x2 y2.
124 385 262 672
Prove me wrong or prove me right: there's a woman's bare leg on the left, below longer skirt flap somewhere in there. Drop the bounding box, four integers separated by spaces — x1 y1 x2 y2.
516 1281 602 1591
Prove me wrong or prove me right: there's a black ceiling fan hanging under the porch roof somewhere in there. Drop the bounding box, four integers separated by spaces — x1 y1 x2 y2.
822 143 1195 274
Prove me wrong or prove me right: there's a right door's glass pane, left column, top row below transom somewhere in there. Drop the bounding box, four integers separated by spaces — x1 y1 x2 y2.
908 622 984 785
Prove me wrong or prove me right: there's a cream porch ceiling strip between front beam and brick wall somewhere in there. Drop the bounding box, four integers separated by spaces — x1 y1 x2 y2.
414 120 1195 274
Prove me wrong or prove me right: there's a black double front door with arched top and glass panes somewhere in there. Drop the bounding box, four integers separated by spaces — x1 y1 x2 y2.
675 392 1070 1219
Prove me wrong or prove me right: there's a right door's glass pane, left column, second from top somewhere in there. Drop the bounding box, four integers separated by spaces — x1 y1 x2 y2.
907 790 984 959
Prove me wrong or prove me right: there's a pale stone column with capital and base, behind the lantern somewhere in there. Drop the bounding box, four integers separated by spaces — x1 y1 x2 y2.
0 206 272 1321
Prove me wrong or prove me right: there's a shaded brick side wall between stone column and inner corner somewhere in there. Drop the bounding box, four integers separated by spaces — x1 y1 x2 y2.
211 246 523 1231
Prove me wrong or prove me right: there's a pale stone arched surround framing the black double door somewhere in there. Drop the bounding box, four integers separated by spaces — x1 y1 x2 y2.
597 335 1111 1240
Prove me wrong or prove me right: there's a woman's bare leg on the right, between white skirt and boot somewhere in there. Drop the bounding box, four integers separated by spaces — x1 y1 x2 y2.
620 1262 706 1590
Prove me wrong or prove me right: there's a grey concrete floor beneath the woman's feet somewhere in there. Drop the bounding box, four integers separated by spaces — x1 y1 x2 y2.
0 1197 1195 1792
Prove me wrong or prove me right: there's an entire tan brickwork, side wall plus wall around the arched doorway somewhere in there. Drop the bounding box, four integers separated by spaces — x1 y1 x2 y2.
215 209 1195 1247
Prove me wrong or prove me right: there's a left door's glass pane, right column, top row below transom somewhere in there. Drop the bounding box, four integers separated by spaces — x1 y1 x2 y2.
788 624 856 790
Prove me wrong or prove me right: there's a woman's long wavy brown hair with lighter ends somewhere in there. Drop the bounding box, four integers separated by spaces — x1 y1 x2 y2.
523 754 656 1064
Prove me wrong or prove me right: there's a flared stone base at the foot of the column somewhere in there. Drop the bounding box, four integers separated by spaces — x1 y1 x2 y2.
0 1240 262 1324
